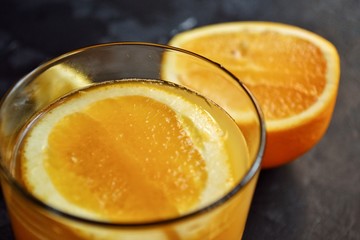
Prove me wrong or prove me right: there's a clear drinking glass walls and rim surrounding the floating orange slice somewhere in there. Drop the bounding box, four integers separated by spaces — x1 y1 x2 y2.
0 42 265 240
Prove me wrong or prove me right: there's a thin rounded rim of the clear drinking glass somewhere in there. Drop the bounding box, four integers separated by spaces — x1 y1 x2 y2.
0 42 266 228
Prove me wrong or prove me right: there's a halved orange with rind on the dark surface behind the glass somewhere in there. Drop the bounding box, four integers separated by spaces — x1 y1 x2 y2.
165 22 340 168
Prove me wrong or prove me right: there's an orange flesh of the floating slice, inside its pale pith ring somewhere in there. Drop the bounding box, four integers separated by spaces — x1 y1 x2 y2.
44 96 207 221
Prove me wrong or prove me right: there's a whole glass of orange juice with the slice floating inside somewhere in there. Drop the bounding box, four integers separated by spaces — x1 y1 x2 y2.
0 42 265 240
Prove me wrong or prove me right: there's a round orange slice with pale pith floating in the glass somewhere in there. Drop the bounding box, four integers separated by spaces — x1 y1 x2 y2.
21 81 242 222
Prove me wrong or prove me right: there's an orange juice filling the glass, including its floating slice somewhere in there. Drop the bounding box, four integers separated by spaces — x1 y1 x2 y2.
4 79 257 240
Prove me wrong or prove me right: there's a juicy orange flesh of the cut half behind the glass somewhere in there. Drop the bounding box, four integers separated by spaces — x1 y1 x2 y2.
180 31 327 120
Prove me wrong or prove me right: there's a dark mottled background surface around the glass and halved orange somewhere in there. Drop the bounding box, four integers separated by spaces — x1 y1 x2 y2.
0 0 360 240
